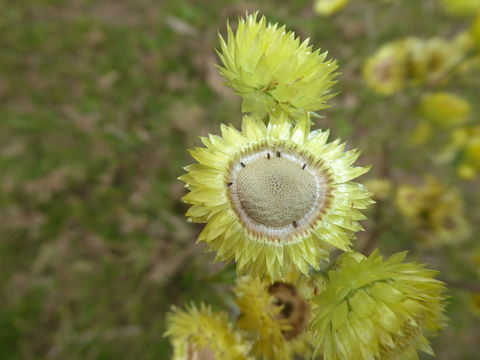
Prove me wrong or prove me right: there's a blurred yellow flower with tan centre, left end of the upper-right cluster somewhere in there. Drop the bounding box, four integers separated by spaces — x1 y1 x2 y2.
363 41 406 96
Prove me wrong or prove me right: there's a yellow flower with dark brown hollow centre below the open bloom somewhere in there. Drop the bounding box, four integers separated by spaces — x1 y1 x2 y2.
234 277 311 360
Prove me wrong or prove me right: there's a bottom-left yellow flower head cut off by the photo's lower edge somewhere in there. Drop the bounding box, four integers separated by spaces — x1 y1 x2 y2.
165 304 249 360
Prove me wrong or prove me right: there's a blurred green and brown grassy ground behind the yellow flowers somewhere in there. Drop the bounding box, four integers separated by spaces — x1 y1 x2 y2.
0 0 480 360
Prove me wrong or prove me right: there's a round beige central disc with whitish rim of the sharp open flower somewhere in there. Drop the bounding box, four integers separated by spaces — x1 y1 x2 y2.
227 148 330 241
